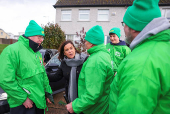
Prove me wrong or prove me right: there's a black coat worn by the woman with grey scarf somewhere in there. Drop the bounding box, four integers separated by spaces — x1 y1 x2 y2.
48 56 88 96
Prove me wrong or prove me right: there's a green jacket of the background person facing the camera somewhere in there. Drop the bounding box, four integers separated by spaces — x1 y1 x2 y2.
106 40 131 72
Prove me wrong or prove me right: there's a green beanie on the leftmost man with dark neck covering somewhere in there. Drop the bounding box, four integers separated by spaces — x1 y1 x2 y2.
25 20 45 37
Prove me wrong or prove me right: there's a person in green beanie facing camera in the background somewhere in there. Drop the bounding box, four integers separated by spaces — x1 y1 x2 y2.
106 27 131 74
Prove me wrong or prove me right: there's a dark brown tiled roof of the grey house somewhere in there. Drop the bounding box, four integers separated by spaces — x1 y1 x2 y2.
54 0 170 8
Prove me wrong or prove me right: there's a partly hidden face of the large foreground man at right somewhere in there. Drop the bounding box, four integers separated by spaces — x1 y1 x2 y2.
124 24 133 44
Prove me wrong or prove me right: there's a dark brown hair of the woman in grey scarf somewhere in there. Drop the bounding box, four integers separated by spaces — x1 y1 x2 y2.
58 40 80 61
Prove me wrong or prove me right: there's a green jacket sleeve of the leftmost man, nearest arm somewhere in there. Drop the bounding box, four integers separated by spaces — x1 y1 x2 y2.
0 47 27 104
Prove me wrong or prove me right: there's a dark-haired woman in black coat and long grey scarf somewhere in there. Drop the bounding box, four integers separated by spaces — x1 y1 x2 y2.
49 41 88 112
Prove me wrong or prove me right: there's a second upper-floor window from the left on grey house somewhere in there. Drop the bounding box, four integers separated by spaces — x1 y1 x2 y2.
79 9 90 21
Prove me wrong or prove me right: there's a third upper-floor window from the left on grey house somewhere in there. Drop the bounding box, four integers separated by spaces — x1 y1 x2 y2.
98 9 109 21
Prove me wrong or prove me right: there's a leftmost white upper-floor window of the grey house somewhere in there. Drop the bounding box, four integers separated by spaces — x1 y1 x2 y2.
61 10 71 21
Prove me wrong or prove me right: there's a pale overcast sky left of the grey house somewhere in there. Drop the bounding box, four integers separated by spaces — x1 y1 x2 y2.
0 0 56 35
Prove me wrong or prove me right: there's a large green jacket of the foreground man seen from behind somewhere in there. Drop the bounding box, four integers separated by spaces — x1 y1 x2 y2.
109 30 170 114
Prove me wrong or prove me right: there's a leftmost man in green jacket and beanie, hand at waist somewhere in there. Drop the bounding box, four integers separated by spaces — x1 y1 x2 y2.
0 20 52 114
